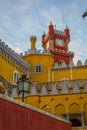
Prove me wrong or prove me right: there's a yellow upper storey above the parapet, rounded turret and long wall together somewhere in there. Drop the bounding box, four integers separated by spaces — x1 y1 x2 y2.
23 54 87 83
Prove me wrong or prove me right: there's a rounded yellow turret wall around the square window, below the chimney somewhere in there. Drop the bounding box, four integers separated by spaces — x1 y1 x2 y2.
23 54 53 82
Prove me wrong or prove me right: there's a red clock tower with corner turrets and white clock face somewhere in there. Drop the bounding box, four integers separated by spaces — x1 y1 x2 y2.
42 22 74 66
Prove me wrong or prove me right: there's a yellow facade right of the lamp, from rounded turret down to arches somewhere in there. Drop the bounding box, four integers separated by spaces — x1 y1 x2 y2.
23 34 87 129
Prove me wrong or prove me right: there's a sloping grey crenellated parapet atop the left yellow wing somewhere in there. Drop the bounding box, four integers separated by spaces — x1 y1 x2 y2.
0 40 30 72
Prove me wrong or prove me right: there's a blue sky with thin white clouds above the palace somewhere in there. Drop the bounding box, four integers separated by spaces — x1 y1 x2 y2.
0 0 87 64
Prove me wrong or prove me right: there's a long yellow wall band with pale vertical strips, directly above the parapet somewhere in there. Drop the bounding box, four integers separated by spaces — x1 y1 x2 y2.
28 67 87 83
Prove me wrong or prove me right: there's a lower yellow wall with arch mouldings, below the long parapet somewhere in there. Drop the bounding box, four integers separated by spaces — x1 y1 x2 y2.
19 93 87 120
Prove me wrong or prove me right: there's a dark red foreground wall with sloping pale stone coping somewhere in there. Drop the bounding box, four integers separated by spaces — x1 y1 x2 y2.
0 95 71 130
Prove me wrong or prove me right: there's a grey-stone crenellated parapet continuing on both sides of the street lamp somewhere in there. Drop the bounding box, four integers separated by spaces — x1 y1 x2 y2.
5 79 87 98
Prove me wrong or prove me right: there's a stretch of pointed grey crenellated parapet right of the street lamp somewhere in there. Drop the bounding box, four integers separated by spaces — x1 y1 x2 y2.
29 79 87 96
